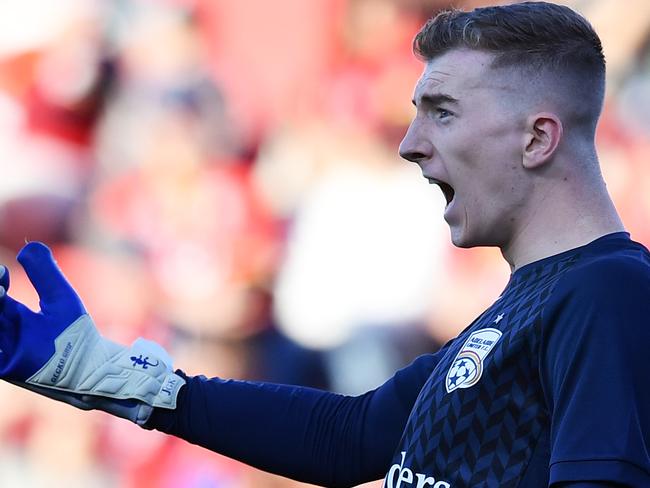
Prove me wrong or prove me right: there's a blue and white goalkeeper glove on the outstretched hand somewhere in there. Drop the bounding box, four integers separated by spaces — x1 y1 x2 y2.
0 242 185 425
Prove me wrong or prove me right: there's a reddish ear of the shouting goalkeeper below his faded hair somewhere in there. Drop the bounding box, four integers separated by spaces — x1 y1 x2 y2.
522 112 563 169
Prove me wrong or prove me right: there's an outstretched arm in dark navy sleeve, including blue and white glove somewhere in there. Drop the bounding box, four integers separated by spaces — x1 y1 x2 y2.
0 243 437 486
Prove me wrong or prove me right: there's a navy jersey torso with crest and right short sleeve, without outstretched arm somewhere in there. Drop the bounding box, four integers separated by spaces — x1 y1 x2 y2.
385 233 650 488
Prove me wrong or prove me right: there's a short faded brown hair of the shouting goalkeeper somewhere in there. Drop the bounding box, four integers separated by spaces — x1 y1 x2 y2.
413 2 605 129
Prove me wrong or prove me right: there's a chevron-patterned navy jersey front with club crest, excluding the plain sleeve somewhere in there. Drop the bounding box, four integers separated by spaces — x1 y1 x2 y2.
384 234 650 488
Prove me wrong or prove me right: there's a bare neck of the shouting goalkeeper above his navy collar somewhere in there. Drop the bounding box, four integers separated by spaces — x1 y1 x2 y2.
501 173 625 271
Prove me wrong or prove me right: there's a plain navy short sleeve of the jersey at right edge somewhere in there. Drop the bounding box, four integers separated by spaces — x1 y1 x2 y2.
540 239 650 486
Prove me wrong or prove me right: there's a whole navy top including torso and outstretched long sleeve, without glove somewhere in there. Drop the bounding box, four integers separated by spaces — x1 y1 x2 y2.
149 233 650 488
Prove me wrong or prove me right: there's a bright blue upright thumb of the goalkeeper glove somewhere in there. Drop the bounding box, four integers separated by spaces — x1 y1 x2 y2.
17 242 86 322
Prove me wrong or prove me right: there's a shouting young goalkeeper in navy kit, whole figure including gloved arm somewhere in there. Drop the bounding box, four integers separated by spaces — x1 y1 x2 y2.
0 2 650 488
